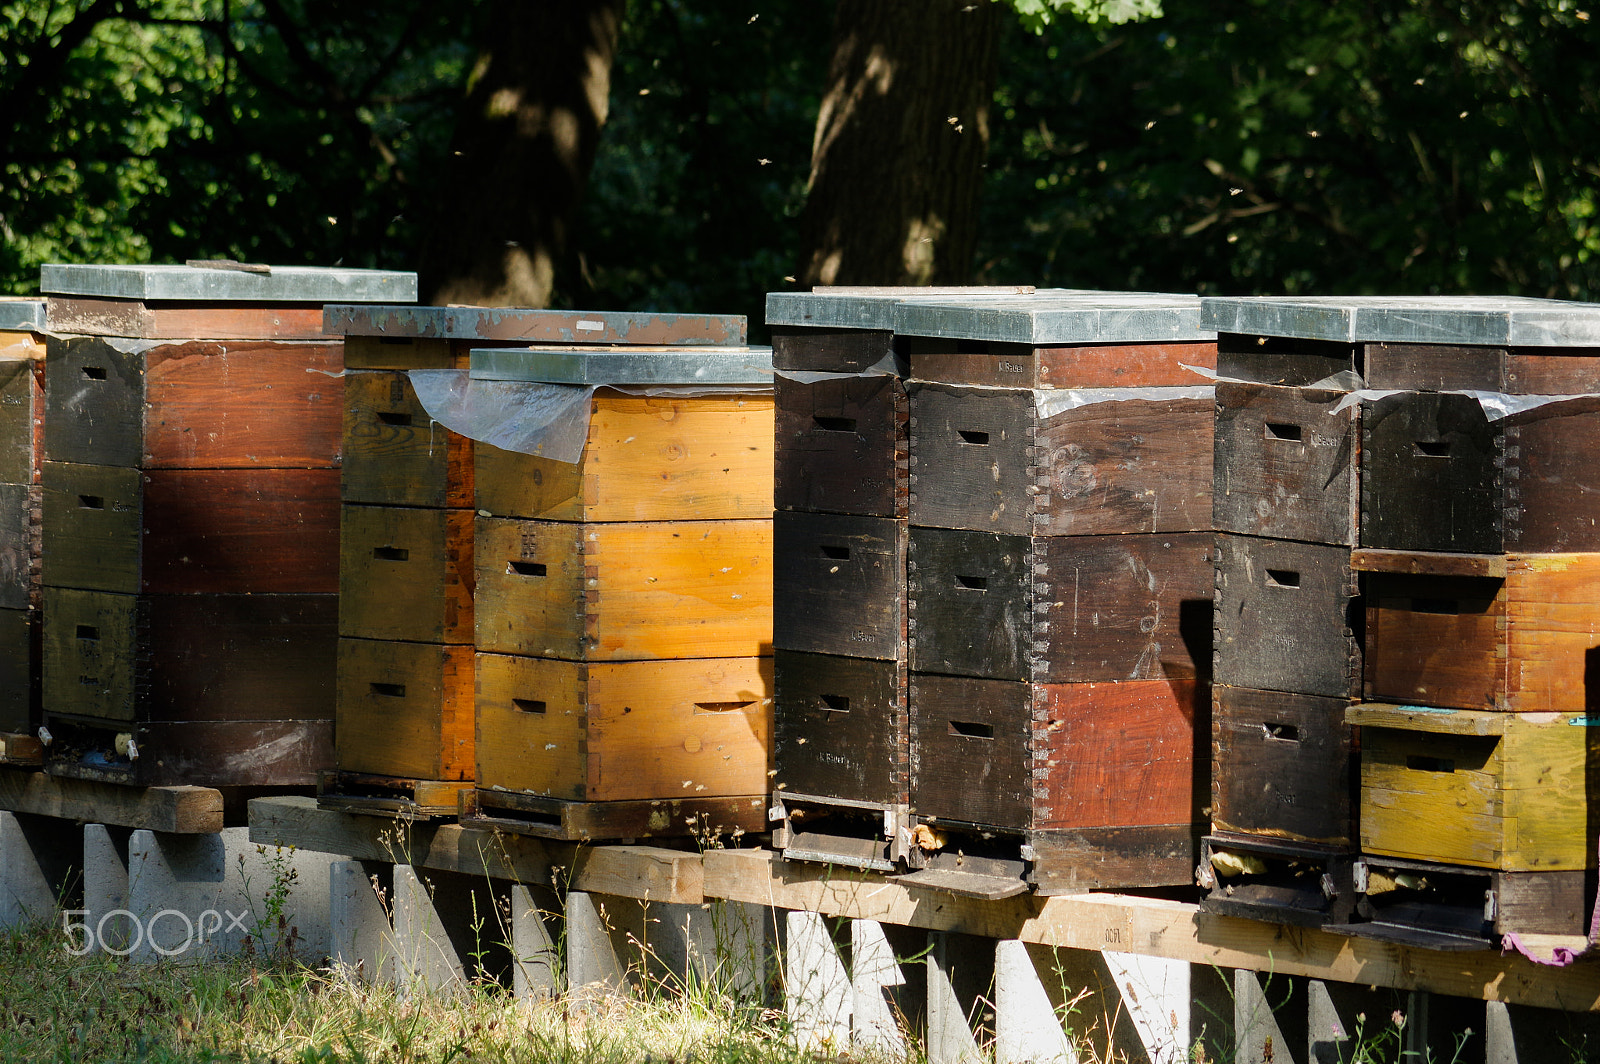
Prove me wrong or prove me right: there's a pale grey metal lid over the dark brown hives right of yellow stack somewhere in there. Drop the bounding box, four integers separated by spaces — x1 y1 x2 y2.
766 288 1216 344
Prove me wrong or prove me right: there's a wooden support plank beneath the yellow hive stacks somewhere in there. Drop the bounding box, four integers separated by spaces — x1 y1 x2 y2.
250 795 704 906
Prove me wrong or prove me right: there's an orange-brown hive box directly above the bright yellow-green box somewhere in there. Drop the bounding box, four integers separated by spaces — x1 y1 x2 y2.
1355 550 1600 712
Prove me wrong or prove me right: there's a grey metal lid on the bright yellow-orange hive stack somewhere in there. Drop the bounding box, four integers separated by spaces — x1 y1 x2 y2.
470 347 773 386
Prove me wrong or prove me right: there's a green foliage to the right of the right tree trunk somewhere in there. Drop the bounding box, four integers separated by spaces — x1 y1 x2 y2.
981 0 1600 299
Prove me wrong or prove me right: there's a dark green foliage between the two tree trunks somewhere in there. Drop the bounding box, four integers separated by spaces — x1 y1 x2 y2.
572 0 832 334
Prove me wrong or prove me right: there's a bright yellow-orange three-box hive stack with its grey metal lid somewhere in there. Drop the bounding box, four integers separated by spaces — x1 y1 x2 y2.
467 340 773 838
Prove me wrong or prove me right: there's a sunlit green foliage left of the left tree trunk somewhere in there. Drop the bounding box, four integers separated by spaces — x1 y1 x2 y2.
0 0 475 293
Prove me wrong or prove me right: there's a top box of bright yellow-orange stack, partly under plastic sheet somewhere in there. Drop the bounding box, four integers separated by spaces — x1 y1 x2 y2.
477 389 773 522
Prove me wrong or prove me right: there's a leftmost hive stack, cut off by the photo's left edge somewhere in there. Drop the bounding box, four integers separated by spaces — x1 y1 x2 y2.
0 299 45 763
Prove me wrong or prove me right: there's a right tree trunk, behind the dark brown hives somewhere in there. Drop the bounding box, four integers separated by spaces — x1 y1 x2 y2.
800 0 1002 285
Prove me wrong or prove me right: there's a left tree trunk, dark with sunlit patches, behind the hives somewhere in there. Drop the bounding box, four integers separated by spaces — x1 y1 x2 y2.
419 0 624 307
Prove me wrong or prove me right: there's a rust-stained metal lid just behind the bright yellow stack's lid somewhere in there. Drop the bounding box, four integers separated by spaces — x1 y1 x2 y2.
322 306 747 347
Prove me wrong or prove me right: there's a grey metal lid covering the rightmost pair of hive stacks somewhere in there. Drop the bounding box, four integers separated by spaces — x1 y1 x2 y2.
1200 296 1600 347
